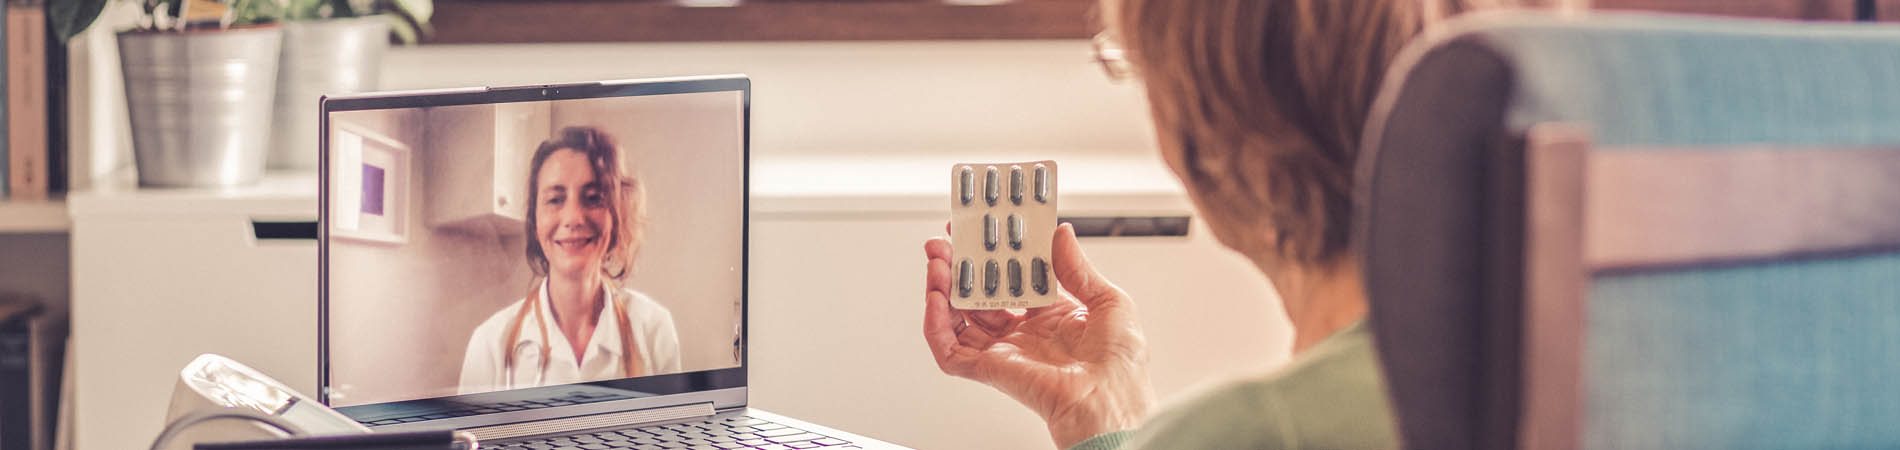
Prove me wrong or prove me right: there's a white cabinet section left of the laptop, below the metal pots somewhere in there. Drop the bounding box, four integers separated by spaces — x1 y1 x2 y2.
68 175 317 450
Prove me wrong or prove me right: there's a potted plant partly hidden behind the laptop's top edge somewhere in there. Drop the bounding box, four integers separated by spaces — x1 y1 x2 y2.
270 0 433 169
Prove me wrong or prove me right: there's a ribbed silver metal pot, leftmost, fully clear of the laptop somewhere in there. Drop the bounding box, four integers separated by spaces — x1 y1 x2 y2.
118 27 283 186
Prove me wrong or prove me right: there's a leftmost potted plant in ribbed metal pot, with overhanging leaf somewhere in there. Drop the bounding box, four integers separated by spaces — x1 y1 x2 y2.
48 0 283 186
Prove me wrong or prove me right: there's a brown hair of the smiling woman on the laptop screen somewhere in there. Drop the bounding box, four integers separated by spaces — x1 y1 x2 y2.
524 127 646 281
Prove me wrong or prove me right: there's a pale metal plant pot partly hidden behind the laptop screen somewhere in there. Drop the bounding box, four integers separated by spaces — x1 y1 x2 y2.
270 15 390 169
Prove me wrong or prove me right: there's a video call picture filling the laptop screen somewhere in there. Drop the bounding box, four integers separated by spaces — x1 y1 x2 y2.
325 91 745 406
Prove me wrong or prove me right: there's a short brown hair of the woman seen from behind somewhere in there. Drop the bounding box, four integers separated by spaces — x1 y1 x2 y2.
1102 0 1509 264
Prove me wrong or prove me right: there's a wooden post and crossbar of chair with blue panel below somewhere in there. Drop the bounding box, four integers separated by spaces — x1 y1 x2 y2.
1518 123 1900 450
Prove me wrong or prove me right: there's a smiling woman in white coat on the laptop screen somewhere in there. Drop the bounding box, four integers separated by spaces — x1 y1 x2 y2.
460 127 680 393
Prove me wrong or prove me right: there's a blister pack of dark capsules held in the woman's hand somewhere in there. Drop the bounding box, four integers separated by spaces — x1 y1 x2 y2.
950 161 1058 309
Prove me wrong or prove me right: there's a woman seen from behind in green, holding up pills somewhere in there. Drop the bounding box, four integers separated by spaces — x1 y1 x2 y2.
923 0 1499 448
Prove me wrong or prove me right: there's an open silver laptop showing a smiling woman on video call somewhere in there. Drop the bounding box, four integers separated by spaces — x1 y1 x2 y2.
317 76 899 450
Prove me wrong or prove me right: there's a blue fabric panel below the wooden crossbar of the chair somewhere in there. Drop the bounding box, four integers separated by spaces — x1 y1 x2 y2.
1583 253 1900 448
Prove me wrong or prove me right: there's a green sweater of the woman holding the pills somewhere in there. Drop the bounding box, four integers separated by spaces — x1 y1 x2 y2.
1070 321 1398 450
